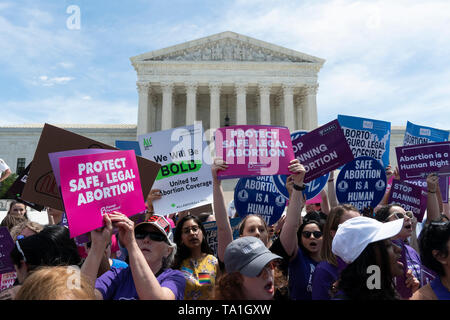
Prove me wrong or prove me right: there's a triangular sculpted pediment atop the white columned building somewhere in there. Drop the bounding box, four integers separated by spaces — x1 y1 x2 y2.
131 31 325 65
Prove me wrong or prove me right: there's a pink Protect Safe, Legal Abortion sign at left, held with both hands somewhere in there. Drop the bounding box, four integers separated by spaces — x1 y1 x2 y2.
59 150 145 238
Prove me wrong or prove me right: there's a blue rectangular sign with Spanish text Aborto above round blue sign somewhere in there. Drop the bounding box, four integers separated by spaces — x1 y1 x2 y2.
338 115 391 168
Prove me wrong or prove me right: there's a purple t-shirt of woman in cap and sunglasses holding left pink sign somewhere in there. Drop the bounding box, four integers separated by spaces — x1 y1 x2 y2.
95 267 186 300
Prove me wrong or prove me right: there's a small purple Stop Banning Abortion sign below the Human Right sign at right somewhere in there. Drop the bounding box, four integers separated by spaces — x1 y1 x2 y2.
389 179 427 222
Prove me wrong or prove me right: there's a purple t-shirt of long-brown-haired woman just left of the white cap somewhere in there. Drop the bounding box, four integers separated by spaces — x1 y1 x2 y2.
312 261 339 300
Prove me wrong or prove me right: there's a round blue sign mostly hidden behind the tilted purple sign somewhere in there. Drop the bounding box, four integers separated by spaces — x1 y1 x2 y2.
272 130 330 200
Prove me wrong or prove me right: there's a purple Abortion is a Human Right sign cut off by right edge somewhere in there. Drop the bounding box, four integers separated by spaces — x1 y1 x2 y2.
395 141 450 180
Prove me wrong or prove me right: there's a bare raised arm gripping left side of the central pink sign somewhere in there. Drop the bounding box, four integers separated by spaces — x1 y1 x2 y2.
211 158 233 261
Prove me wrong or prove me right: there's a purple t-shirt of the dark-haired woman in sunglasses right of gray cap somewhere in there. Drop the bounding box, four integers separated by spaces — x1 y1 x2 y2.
289 248 317 300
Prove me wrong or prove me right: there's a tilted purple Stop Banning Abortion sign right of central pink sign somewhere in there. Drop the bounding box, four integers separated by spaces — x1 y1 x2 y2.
292 120 354 183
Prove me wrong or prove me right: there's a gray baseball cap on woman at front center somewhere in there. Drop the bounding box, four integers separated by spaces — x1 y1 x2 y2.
224 236 281 278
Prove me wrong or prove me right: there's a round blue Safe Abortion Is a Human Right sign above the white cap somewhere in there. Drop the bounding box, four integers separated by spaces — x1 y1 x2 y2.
336 157 386 211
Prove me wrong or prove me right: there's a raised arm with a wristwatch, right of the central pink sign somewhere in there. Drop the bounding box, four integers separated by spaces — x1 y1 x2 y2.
280 159 306 259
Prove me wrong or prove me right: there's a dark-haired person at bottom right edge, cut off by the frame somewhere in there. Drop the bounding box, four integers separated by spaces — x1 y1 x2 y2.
411 221 450 300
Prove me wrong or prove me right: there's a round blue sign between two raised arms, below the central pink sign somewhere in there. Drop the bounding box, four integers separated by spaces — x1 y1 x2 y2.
234 176 286 225
